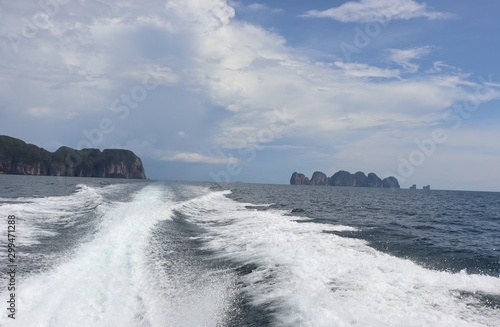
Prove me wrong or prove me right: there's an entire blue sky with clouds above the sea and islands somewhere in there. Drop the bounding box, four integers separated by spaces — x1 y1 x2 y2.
0 0 500 191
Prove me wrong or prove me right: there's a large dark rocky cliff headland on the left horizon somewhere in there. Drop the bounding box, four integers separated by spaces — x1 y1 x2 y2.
0 135 146 179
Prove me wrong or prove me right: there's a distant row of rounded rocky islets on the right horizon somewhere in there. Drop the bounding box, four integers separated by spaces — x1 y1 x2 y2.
290 170 400 188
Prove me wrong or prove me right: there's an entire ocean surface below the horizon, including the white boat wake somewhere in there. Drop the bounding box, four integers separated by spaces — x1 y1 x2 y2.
0 175 500 327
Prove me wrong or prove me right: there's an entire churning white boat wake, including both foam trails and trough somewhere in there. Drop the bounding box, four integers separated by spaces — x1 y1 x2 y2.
0 183 500 327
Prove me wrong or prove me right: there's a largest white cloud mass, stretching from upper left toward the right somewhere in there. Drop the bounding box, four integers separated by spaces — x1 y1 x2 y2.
0 0 467 148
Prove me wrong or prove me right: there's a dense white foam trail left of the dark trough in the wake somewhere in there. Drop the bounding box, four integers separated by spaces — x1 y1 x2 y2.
0 185 236 327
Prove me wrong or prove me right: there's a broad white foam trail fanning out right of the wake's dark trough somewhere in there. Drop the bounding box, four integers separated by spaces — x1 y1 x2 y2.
175 191 500 327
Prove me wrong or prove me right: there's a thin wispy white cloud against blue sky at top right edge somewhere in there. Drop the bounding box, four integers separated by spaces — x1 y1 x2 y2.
303 0 454 23
